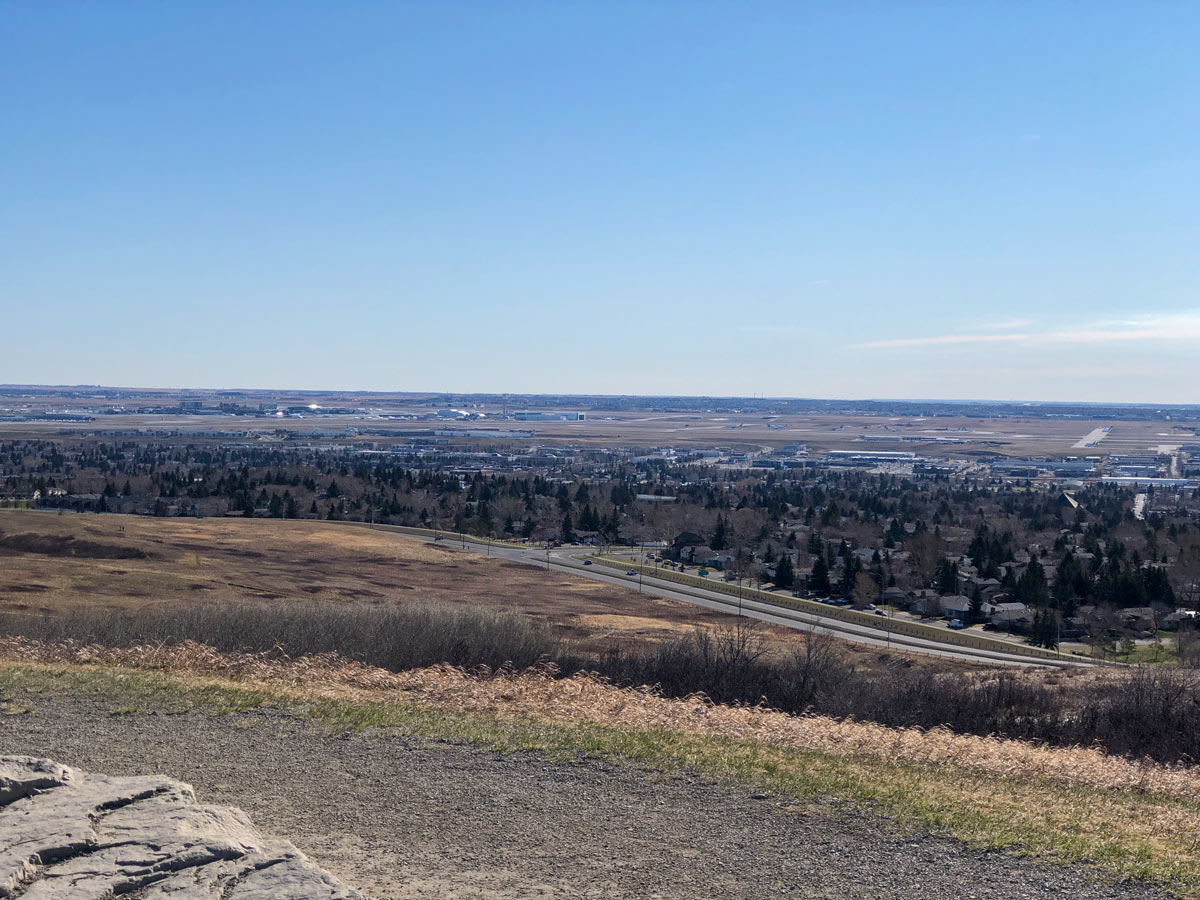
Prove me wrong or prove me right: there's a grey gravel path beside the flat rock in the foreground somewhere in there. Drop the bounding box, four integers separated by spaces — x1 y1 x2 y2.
0 695 1166 900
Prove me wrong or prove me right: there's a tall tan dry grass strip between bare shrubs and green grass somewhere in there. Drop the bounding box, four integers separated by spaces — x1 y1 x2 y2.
0 638 1200 806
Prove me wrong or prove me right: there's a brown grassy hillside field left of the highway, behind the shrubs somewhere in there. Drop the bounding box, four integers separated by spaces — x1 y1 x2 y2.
0 510 875 656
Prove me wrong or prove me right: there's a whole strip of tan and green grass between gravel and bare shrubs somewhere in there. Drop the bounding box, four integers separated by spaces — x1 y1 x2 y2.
0 640 1200 899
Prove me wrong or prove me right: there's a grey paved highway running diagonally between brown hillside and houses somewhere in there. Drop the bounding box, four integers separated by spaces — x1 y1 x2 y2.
400 533 1090 667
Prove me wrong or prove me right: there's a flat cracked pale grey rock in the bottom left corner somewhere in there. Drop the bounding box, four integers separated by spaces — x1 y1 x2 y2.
0 756 364 900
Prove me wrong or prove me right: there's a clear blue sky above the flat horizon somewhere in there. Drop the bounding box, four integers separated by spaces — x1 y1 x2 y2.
0 0 1200 402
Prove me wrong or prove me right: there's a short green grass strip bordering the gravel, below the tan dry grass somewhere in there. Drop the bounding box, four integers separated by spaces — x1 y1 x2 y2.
0 666 1200 898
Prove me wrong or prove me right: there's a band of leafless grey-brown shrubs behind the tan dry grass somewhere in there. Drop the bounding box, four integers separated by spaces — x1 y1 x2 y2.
0 601 1200 762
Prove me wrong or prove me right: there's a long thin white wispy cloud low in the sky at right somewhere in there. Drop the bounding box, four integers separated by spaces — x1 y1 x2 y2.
856 311 1200 349
